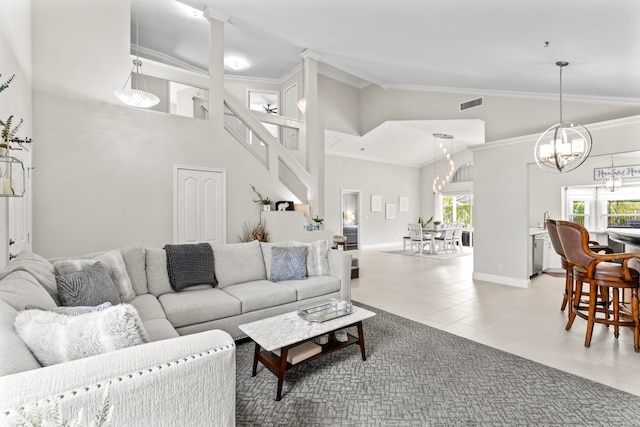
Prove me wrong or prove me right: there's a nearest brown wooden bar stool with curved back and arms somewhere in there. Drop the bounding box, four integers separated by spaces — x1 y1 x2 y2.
556 220 640 353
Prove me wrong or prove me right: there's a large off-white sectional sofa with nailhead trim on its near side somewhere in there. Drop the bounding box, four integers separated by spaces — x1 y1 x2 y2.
0 242 351 426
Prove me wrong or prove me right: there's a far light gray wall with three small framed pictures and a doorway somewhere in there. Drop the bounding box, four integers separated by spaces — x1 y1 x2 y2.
325 155 420 247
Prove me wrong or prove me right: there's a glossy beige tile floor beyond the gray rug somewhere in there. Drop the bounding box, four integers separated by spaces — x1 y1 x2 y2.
351 247 640 395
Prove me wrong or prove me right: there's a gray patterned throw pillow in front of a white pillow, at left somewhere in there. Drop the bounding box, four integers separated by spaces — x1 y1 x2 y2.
56 261 120 307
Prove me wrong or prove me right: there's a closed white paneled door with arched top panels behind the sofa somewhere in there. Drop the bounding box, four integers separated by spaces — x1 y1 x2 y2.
173 166 227 243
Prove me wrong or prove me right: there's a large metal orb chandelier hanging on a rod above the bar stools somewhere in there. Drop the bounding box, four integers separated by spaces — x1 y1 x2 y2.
535 61 592 173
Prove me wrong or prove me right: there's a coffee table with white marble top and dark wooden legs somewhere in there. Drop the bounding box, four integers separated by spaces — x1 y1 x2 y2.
239 306 376 400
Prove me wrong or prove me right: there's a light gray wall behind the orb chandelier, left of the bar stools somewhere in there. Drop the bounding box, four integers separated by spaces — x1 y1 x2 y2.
473 117 640 286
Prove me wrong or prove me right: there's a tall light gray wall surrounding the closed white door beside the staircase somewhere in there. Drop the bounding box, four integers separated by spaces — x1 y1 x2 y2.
33 0 304 257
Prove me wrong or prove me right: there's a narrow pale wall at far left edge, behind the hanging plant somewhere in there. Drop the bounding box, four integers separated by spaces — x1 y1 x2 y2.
0 1 35 267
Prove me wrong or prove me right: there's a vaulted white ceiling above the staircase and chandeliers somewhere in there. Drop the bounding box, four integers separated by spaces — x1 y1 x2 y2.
138 0 640 167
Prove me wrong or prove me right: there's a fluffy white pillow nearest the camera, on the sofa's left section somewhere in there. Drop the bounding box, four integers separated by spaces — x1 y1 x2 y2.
14 304 149 366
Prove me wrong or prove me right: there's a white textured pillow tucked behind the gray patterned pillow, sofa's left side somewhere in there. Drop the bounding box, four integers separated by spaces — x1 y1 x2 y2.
53 250 136 302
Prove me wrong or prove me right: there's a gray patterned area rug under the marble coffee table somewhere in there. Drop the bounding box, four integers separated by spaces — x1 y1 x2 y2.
236 303 640 426
